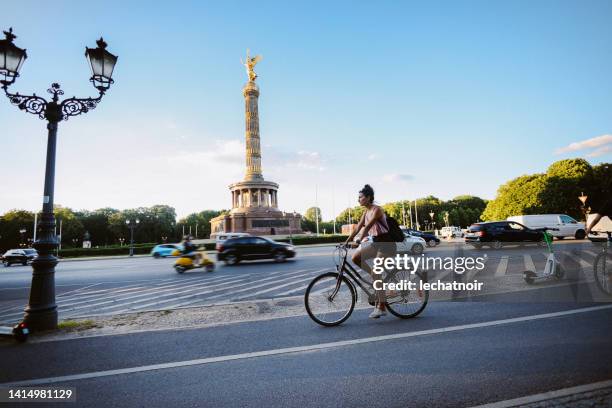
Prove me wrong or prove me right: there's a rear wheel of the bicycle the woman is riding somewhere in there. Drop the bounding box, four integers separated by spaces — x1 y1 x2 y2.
384 271 429 319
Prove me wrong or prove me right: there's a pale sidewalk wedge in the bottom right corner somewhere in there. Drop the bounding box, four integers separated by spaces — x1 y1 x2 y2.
473 380 612 408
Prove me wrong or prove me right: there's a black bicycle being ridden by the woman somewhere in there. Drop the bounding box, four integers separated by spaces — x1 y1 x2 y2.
304 244 429 326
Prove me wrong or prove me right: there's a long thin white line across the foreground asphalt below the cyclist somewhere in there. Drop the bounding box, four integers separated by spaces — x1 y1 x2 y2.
0 305 612 387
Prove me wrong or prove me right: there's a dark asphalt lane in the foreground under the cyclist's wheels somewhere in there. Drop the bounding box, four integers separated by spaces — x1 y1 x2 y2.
0 298 612 408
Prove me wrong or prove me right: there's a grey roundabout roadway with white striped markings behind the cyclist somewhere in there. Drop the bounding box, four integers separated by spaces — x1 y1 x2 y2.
0 240 598 324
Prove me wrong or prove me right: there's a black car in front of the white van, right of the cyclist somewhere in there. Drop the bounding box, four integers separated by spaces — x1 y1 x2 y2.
465 221 544 249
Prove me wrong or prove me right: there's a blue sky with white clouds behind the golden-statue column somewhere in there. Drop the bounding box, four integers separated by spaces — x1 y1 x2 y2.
0 0 612 219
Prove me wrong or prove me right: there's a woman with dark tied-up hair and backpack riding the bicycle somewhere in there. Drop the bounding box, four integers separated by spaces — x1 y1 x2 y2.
345 184 389 319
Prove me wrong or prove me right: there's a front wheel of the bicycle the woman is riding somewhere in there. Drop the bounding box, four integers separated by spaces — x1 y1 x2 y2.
304 272 357 326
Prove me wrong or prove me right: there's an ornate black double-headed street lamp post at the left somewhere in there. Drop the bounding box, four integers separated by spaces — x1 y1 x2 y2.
0 28 117 330
